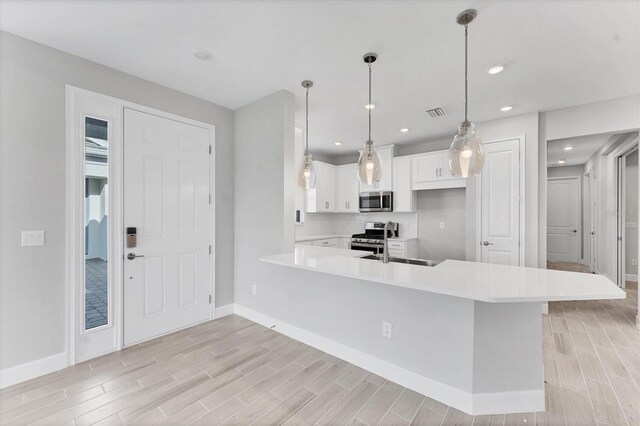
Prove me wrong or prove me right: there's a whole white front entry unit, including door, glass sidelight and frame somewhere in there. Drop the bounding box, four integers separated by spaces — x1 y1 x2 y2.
67 86 215 365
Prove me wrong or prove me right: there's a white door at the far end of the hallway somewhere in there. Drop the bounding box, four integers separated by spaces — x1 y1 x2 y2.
547 177 580 263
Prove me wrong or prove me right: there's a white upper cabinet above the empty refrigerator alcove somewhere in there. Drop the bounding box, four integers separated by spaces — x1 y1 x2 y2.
411 150 466 191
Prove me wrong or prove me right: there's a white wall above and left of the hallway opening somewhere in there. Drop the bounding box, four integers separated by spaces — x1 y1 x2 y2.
538 95 640 268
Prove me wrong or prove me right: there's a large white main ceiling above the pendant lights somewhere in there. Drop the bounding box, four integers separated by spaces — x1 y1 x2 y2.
0 0 640 155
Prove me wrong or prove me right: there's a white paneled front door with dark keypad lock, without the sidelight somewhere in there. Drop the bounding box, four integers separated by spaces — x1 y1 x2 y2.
124 109 211 345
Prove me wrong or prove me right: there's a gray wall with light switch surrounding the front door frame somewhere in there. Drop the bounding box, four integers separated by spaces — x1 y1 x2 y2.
0 32 235 369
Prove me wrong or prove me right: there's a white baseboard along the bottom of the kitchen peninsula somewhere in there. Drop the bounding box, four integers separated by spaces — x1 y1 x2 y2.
233 304 544 415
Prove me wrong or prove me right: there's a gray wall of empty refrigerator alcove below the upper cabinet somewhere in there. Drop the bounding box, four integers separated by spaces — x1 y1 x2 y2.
418 188 464 261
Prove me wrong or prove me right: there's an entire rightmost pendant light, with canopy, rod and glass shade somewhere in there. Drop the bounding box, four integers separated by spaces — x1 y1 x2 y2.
449 9 484 178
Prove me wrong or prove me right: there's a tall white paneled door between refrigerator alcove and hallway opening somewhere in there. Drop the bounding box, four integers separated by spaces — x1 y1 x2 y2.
480 139 520 265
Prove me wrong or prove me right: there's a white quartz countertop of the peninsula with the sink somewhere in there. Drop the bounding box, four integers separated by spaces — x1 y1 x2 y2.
260 246 625 303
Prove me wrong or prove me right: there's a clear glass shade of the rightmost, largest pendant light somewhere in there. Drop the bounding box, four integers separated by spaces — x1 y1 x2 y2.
449 121 484 178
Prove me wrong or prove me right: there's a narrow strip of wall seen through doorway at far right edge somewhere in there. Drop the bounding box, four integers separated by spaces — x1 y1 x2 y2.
625 150 638 276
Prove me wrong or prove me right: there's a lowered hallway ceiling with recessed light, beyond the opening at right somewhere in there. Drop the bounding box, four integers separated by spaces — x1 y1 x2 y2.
547 133 616 167
